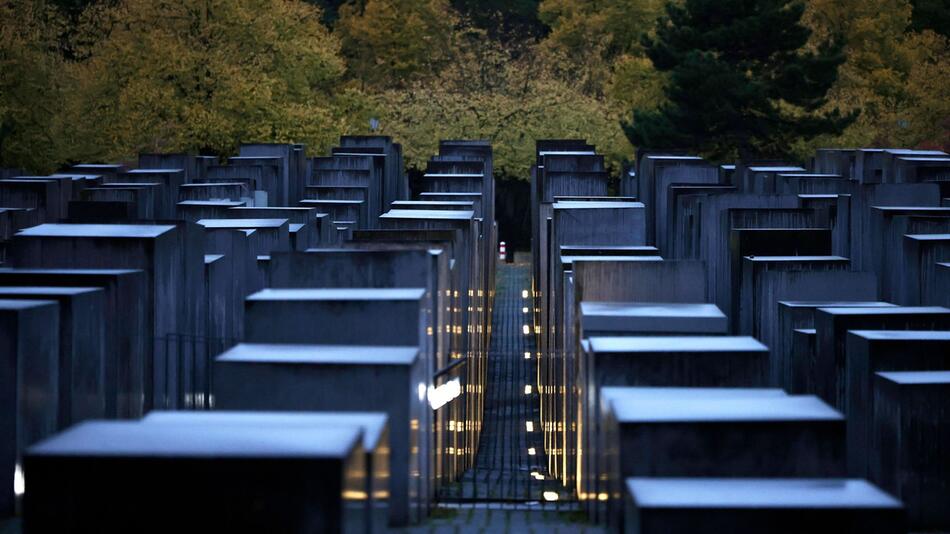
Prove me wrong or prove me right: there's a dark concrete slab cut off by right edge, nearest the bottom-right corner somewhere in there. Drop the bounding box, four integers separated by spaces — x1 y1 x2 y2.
869 372 950 531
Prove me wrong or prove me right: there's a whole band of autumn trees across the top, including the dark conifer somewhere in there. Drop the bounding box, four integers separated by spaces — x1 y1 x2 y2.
0 0 950 179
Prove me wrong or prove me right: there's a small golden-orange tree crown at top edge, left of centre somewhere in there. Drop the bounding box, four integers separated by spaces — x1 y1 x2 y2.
334 0 458 89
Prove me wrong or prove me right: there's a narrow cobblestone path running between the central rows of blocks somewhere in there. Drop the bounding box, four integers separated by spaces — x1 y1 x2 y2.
402 263 603 534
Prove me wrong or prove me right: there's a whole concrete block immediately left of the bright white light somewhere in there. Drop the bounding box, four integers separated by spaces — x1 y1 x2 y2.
214 343 429 526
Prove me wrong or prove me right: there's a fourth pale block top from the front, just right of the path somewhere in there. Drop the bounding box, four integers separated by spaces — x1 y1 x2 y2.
589 336 769 353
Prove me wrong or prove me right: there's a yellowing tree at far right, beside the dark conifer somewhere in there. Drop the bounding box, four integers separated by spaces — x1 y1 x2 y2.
798 0 950 154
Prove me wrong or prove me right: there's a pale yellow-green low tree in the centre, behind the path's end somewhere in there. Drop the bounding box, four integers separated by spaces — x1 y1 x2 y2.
378 30 632 179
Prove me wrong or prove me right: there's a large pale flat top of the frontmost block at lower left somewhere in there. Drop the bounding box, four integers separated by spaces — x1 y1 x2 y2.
27 421 361 458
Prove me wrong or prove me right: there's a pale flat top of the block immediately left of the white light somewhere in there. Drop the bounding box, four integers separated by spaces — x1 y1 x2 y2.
221 343 419 365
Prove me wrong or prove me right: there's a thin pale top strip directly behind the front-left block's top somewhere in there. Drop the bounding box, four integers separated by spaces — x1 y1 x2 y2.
142 411 388 451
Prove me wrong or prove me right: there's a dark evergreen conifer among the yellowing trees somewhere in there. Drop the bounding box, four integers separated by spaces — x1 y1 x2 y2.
624 0 855 159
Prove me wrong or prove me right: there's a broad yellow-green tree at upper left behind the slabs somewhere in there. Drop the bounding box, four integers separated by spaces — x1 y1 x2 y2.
63 0 362 160
